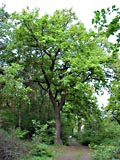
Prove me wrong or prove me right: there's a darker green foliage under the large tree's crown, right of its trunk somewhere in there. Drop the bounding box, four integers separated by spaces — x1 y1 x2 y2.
64 84 101 121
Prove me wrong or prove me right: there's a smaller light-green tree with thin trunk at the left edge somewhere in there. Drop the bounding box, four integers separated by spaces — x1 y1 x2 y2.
0 64 31 129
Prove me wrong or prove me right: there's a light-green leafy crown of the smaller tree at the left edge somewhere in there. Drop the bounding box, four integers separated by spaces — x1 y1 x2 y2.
0 63 31 105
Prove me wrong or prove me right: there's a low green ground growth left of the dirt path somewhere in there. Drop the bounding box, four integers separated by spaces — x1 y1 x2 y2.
19 141 67 160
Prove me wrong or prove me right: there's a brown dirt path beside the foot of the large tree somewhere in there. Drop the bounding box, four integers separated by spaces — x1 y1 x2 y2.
55 141 91 160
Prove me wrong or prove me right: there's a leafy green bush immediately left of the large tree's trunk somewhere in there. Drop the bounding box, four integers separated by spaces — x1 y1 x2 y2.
32 120 55 144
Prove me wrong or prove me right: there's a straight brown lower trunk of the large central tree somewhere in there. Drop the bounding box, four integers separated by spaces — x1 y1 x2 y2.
55 107 62 144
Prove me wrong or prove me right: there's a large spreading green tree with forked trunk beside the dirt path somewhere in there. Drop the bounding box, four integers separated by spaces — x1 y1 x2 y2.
2 9 106 144
